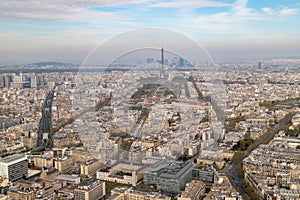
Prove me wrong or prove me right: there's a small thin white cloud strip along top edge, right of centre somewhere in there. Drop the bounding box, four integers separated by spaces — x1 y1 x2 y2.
151 1 231 8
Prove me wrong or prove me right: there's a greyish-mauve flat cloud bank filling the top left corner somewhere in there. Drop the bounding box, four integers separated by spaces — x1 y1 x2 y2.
0 0 147 21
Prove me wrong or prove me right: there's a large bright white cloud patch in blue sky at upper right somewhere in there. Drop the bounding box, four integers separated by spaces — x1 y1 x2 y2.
173 0 297 37
